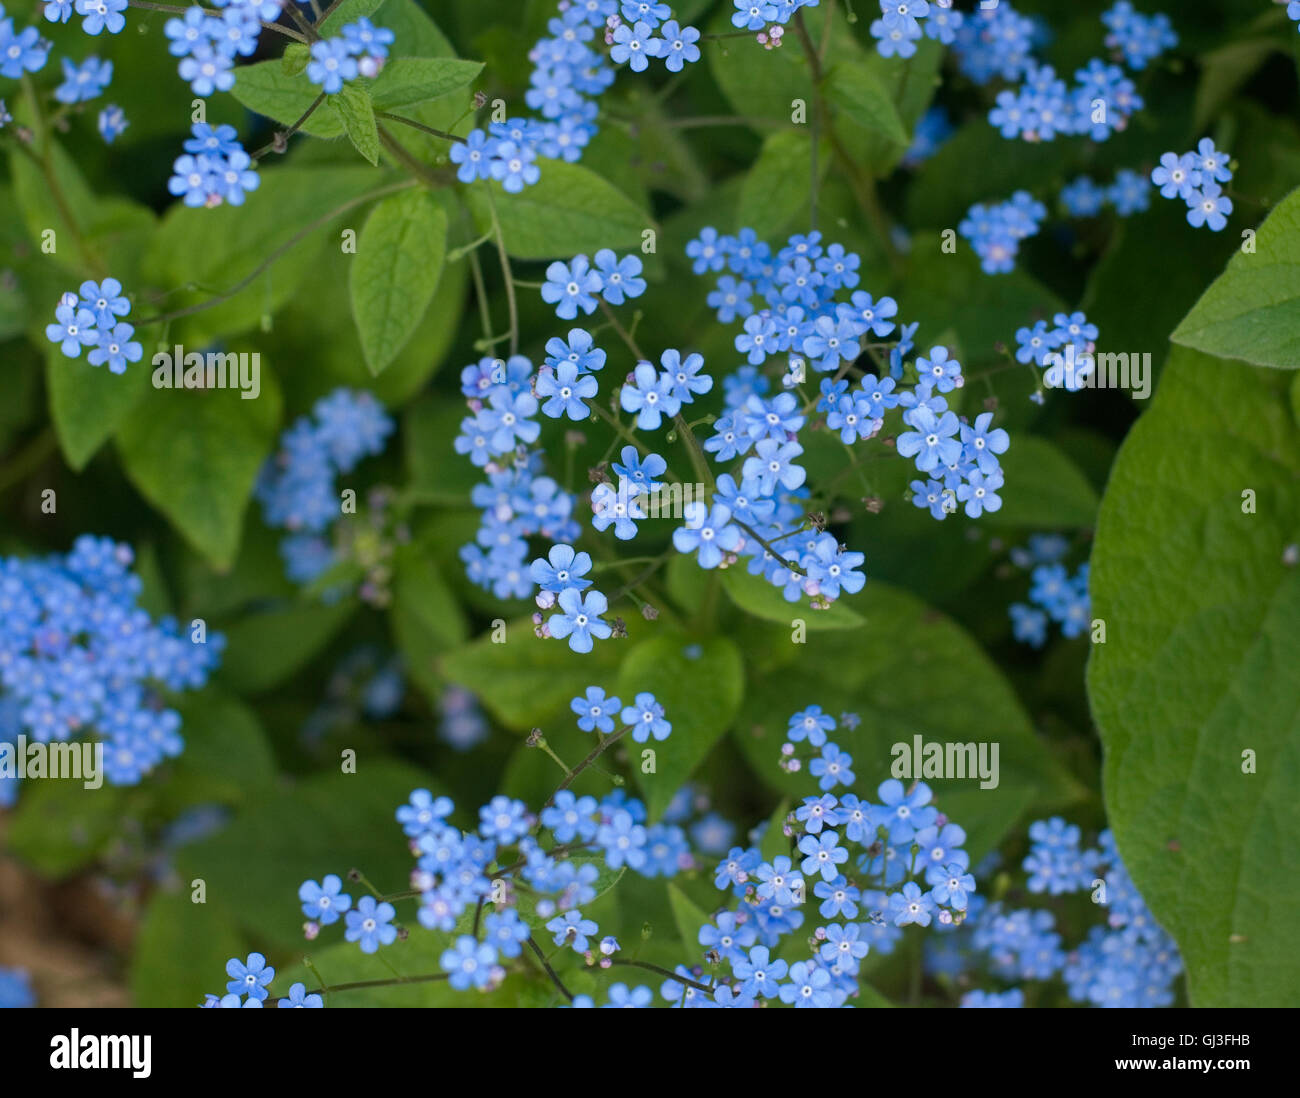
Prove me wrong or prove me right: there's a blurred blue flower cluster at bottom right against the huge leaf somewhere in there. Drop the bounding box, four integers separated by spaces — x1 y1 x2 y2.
926 817 1182 1007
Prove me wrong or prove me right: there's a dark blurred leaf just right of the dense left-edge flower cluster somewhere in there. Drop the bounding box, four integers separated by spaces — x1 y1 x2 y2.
218 599 356 694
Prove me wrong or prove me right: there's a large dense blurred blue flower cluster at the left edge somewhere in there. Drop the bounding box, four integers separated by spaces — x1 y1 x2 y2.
0 534 225 785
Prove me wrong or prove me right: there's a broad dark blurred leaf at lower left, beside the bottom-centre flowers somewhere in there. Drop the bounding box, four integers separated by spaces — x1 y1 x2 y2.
176 751 437 945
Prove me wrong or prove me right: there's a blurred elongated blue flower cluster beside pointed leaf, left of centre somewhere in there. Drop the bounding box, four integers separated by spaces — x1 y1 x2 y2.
255 389 394 583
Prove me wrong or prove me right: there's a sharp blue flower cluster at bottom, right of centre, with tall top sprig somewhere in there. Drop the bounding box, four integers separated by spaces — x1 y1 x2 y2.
660 706 976 1007
